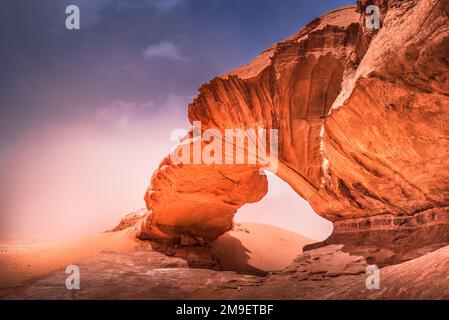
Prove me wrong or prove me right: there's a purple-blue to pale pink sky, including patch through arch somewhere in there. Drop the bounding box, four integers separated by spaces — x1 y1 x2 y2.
0 0 353 239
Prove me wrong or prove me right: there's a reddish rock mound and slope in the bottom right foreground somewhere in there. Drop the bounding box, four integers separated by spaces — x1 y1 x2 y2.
230 245 449 300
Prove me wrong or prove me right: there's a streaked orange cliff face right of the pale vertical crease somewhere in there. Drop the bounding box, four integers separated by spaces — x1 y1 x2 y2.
316 1 449 223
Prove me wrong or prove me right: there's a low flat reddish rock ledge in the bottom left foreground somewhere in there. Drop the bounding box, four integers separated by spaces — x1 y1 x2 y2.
0 244 263 300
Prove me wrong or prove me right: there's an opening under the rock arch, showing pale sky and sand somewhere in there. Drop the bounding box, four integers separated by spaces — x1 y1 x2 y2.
208 172 333 275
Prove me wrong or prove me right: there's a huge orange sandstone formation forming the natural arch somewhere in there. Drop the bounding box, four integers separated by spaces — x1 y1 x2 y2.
132 0 449 244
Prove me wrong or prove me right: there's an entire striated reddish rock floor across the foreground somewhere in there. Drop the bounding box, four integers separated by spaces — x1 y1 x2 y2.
7 244 449 300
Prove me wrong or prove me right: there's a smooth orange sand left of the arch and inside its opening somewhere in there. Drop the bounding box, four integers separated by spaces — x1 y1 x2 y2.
0 223 314 288
